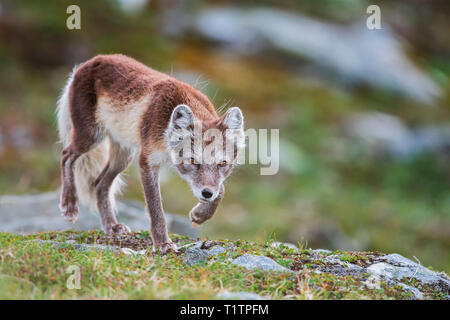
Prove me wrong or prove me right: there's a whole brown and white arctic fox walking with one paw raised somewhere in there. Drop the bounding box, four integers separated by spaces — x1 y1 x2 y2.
58 54 245 254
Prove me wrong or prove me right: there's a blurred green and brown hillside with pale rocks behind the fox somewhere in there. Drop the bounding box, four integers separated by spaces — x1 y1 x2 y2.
0 0 450 271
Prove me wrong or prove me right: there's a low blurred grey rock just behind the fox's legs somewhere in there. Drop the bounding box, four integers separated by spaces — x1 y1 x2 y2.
0 191 198 238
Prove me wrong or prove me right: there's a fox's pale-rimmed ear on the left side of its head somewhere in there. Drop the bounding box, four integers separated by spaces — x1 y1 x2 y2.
167 104 195 148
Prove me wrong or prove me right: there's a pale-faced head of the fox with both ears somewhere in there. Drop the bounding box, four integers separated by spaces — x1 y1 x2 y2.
166 105 245 202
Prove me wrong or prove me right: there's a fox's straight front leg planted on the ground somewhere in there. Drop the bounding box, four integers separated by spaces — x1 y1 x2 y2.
139 157 177 254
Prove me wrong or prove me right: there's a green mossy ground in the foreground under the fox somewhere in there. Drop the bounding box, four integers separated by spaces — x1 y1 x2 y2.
0 231 441 299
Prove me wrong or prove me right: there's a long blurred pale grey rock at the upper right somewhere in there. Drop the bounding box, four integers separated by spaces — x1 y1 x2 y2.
174 7 442 103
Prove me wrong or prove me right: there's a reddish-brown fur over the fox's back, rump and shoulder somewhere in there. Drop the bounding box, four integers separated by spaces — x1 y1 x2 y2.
70 54 219 146
